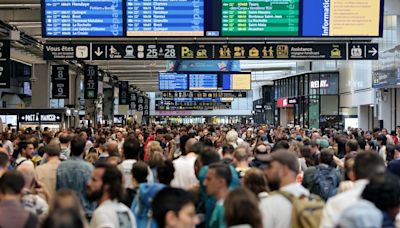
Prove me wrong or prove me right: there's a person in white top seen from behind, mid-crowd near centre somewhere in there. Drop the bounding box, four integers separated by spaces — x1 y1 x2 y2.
171 136 199 189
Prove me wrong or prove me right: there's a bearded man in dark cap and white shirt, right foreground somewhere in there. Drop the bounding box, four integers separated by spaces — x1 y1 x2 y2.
260 150 310 228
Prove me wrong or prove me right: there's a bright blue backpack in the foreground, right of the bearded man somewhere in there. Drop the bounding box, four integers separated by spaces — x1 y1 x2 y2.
131 183 165 228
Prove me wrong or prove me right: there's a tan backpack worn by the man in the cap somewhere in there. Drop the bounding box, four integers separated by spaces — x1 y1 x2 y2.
278 191 325 228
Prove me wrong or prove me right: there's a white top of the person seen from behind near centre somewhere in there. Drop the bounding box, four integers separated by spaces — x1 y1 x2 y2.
171 155 199 189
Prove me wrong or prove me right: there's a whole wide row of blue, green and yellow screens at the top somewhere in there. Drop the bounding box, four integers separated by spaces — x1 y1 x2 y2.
41 0 384 38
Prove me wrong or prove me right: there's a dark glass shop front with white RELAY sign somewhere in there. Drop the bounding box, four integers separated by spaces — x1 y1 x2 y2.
274 71 343 129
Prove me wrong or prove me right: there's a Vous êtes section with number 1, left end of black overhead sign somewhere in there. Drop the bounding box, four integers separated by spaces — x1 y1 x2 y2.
43 43 91 60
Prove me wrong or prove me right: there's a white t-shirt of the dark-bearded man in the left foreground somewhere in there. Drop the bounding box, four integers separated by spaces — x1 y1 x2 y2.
90 200 136 228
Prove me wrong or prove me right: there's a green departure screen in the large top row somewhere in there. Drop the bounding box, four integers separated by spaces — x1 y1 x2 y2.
221 0 300 36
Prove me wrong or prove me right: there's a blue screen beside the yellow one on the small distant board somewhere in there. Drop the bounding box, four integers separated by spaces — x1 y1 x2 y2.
189 74 218 90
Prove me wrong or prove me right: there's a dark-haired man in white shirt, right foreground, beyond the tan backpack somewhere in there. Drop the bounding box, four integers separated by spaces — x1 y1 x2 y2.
320 151 386 228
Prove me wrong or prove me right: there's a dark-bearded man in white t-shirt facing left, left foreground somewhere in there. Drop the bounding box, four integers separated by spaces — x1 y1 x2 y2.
87 162 136 228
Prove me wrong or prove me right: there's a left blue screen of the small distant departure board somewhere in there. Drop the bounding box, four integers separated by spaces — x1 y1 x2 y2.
159 73 188 91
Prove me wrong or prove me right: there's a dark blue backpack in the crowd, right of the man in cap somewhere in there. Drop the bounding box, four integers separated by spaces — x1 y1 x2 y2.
310 167 338 201
